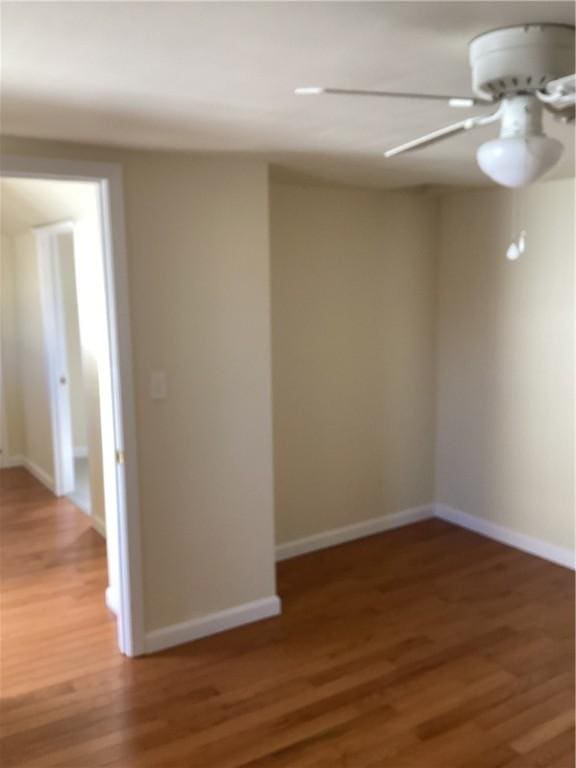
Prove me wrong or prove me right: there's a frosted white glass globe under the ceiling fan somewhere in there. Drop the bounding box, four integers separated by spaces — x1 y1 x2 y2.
476 134 563 187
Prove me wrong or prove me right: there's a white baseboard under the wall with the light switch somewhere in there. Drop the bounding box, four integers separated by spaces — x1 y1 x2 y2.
144 595 281 653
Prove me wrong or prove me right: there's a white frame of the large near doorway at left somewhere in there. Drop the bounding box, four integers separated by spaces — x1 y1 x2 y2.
0 155 144 656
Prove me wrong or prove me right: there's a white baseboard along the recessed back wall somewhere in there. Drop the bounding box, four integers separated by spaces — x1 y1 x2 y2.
276 504 434 561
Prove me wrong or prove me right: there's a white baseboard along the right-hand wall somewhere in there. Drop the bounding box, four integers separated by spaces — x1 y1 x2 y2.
434 504 575 569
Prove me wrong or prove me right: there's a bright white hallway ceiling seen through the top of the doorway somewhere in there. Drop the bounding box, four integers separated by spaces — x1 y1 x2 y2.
0 178 98 235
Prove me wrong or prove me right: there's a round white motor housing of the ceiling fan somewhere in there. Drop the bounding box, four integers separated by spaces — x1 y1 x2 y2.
470 24 574 99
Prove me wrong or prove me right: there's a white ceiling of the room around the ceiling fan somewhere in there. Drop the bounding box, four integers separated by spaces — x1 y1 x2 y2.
2 2 574 187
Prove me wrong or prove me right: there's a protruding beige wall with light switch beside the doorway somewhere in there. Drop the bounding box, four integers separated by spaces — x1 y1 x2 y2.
3 139 275 629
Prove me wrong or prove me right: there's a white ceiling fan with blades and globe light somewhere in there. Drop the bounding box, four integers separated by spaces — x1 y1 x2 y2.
295 24 576 187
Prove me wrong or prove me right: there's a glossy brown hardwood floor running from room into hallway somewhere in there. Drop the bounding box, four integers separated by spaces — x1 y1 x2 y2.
0 469 574 768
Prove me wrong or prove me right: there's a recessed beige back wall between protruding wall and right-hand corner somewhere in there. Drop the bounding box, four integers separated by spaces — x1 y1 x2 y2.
271 183 437 543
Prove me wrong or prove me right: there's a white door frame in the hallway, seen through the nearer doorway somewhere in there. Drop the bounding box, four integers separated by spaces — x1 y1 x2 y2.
34 221 74 496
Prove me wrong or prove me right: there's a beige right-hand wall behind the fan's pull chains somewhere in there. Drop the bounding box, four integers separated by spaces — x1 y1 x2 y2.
436 180 574 548
